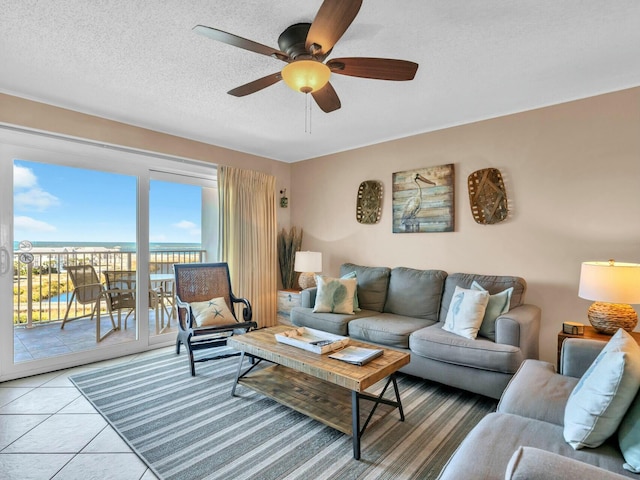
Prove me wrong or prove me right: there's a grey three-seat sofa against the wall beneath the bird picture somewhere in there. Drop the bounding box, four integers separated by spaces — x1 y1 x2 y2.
291 263 540 399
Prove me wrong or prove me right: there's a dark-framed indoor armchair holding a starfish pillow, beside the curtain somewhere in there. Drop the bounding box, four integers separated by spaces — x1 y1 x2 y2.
173 263 258 376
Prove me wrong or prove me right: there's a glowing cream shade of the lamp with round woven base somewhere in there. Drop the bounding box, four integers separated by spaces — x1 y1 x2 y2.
578 260 640 304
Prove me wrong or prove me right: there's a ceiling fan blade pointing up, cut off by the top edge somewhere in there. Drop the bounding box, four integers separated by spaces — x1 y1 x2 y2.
305 0 362 56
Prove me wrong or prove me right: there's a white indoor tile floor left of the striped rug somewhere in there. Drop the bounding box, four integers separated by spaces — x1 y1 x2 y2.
0 347 173 480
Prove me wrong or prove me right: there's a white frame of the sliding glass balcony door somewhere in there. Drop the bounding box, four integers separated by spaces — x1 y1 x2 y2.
0 126 215 381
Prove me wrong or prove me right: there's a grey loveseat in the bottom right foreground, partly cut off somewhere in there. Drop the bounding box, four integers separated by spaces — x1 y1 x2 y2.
439 339 640 480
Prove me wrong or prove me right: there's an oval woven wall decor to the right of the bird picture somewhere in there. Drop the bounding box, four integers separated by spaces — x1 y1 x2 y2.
468 168 509 225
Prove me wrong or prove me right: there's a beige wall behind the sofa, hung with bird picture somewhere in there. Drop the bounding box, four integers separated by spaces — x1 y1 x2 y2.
290 88 640 362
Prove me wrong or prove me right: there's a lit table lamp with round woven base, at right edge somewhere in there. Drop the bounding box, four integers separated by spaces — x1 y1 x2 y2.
578 260 640 335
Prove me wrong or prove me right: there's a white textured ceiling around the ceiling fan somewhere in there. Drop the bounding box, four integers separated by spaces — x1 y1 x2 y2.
0 0 640 162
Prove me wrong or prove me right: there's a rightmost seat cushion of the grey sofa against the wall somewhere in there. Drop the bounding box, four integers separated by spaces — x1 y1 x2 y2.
409 322 523 374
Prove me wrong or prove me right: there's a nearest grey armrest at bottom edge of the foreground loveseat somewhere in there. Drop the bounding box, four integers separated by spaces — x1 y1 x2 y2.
504 447 627 480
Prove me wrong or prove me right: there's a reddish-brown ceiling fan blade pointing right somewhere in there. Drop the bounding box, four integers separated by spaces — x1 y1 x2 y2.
327 57 418 80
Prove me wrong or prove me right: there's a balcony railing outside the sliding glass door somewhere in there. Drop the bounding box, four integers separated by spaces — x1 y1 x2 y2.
13 248 205 327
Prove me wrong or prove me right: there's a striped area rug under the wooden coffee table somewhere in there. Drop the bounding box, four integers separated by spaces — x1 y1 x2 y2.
71 352 496 480
